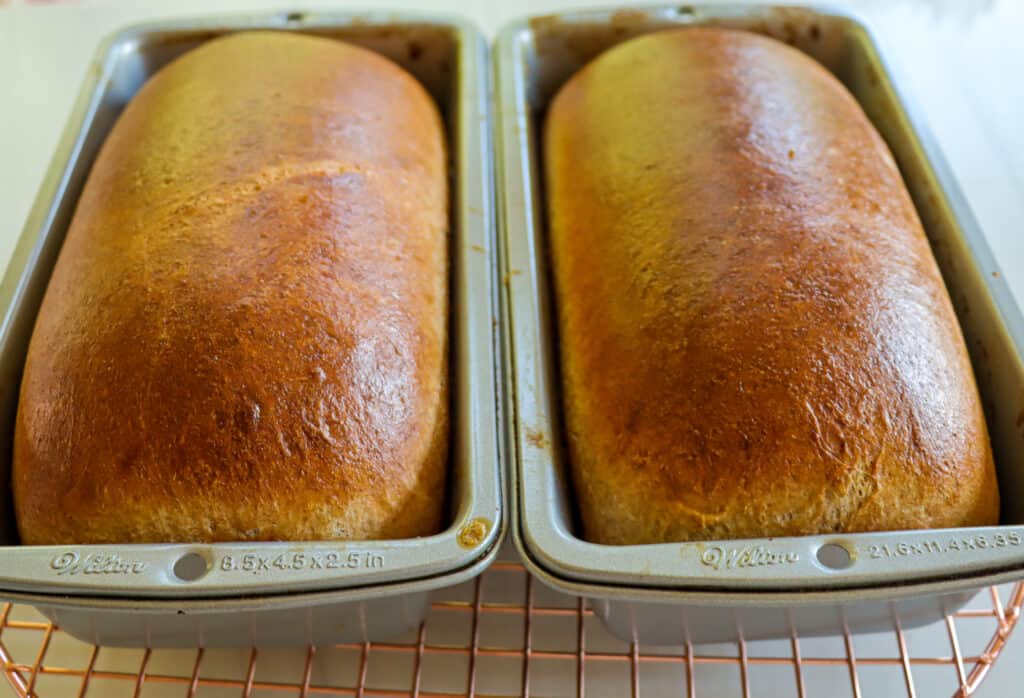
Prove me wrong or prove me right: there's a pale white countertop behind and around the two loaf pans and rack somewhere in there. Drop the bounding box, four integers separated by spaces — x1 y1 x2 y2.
0 0 1024 698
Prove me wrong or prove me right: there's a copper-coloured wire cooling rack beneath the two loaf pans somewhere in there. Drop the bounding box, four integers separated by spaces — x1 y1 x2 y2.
0 540 1024 698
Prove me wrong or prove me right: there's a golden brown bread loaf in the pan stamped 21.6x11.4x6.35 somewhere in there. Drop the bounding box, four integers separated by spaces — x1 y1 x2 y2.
544 28 998 544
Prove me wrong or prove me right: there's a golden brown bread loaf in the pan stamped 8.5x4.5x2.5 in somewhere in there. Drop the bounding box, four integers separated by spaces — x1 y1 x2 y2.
13 33 449 543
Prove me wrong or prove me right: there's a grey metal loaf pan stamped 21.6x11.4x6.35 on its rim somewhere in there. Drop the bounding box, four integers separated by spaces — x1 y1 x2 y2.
496 5 1024 644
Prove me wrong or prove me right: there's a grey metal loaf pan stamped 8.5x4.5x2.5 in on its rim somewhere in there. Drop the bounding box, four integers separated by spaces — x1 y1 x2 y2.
0 12 504 647
